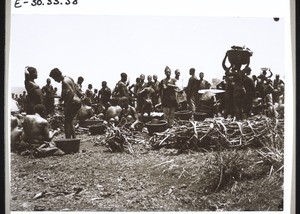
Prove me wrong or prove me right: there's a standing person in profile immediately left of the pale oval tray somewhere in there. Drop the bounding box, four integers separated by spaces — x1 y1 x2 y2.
186 68 198 112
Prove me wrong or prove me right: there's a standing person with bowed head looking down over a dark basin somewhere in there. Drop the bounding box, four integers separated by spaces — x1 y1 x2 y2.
49 68 81 138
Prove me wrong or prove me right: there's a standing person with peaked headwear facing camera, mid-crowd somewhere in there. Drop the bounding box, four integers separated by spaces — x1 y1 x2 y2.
160 66 177 128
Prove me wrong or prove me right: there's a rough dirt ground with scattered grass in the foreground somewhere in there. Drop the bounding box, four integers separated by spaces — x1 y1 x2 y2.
10 131 283 211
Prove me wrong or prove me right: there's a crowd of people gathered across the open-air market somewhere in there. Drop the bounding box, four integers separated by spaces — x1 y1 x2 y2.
11 61 284 154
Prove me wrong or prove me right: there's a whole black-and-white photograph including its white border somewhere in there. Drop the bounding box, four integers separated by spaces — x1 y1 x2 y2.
6 0 294 213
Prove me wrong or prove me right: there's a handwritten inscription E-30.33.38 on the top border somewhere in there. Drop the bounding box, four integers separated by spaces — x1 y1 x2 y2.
14 0 78 8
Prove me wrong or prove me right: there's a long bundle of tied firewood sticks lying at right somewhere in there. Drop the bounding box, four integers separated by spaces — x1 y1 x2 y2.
150 116 284 152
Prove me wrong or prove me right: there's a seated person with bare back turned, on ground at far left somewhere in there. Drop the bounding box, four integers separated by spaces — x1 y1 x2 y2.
19 104 63 155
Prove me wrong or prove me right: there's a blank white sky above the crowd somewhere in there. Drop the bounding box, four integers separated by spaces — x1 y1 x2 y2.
9 14 285 92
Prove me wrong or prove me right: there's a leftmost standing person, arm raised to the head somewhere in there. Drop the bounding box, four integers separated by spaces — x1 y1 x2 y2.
24 66 43 114
